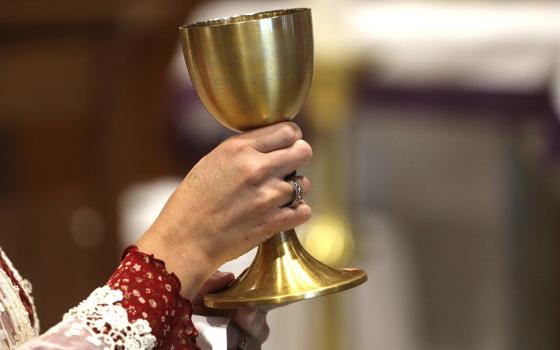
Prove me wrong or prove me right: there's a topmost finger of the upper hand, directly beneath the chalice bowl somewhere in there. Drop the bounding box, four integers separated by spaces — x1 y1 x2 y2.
239 122 302 153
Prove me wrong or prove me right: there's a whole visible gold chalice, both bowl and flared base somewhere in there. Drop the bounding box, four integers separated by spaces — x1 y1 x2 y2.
179 8 367 309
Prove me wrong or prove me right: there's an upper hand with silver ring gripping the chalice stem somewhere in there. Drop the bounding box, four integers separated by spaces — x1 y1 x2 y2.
137 122 312 298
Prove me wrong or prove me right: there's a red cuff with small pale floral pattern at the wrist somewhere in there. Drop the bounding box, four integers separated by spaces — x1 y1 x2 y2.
107 246 199 350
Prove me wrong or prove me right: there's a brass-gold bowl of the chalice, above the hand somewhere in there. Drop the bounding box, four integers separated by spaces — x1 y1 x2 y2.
179 9 313 131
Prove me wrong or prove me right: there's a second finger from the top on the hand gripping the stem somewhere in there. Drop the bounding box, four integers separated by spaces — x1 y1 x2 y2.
262 140 313 178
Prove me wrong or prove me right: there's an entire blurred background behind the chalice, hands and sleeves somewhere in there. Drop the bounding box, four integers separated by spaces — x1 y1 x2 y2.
0 0 560 350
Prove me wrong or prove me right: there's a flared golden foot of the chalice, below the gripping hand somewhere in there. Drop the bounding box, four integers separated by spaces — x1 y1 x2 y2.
204 230 367 309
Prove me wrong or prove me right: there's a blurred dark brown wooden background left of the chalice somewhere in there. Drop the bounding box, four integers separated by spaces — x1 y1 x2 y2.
0 0 199 330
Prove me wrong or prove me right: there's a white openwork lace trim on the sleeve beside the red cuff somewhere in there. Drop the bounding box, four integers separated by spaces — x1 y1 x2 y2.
63 286 156 350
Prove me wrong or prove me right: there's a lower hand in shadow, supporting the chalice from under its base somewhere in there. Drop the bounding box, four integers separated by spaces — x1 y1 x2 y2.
192 271 270 350
